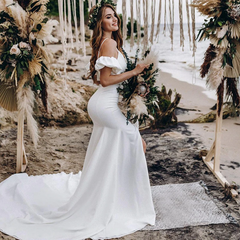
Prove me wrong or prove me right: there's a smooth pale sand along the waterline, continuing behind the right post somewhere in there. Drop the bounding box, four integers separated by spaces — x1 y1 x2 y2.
157 69 240 185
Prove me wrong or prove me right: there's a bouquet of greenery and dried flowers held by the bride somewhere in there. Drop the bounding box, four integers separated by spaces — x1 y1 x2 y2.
117 49 159 124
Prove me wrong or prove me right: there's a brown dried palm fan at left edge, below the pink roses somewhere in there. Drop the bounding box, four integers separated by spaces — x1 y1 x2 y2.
0 81 17 112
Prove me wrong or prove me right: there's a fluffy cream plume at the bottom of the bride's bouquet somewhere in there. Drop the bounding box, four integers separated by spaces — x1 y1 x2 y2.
129 94 148 117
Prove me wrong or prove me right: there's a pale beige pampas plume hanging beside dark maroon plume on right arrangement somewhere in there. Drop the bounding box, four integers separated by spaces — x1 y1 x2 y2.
207 49 225 90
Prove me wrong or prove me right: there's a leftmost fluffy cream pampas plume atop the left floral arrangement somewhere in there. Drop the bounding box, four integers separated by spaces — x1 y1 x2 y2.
8 3 30 38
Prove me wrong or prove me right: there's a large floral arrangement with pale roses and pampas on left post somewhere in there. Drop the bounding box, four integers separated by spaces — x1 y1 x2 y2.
0 0 57 145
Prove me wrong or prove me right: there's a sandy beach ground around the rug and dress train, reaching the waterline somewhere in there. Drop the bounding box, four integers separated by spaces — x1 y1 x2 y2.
0 44 240 240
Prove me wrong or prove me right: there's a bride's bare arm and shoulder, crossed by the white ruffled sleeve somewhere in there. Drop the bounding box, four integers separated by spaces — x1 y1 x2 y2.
100 39 149 87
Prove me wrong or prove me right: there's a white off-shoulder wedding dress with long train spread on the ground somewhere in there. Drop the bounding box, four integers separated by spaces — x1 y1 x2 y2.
0 47 155 240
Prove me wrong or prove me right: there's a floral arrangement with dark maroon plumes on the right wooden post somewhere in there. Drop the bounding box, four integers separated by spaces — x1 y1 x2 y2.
192 0 240 114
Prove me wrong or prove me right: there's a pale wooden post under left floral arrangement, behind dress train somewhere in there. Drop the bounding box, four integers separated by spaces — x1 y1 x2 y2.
16 114 28 173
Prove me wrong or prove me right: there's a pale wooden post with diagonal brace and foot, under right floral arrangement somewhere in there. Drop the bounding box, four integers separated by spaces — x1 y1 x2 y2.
203 100 238 197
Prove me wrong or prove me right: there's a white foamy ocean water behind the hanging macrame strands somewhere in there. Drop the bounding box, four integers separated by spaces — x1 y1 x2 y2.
125 23 217 100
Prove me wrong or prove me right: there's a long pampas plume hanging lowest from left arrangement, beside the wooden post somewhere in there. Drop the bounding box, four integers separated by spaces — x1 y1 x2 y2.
17 87 39 147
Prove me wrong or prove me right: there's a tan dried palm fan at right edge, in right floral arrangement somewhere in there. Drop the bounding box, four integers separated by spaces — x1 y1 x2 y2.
224 41 240 78
